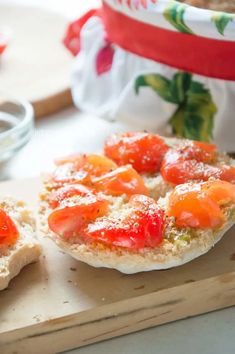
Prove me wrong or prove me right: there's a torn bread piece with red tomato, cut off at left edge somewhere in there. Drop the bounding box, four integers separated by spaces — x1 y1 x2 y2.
0 198 41 290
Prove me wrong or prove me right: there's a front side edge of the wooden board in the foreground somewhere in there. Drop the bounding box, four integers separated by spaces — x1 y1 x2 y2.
0 272 235 354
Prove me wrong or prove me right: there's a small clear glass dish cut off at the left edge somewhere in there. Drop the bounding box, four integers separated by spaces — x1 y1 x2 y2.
0 95 34 166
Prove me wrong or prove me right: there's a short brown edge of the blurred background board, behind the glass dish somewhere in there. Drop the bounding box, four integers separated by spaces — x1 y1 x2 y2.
31 88 73 118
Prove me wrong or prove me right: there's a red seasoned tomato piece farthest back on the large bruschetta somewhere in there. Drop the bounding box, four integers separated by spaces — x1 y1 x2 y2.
104 132 168 173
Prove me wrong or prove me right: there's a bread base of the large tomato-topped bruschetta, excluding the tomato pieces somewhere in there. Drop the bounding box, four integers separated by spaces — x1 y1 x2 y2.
40 138 235 274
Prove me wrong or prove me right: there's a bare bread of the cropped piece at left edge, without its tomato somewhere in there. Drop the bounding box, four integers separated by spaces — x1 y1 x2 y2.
0 198 41 290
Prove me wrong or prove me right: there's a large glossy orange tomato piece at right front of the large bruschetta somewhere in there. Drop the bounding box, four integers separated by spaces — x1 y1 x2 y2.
167 186 224 229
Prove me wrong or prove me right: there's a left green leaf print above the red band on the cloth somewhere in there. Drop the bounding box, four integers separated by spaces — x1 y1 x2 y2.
163 1 193 34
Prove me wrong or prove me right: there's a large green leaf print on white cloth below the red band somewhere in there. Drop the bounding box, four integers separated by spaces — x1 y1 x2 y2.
135 72 217 142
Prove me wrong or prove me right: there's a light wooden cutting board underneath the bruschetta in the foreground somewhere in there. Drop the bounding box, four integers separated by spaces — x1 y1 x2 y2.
0 179 235 354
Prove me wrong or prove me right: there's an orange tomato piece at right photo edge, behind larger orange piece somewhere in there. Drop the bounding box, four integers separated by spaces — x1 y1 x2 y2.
202 181 235 205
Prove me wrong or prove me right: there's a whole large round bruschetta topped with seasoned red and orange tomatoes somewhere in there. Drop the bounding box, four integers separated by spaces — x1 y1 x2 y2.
40 133 235 273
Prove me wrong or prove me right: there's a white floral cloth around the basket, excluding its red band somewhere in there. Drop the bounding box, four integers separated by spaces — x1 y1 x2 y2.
72 0 235 151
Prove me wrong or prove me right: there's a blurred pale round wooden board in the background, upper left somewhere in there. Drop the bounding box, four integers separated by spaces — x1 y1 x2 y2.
0 3 73 117
